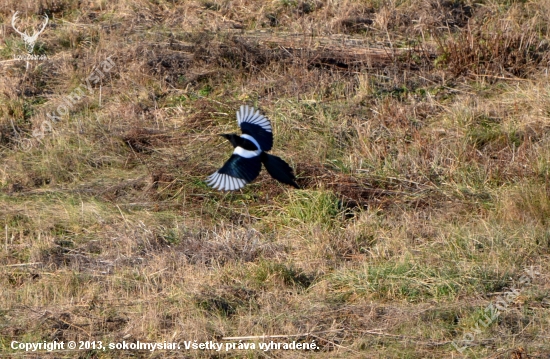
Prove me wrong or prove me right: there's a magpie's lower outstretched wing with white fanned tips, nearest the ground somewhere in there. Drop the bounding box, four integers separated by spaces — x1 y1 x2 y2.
206 154 262 191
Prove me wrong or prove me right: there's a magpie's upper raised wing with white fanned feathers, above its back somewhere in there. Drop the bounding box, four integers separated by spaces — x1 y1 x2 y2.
237 105 273 151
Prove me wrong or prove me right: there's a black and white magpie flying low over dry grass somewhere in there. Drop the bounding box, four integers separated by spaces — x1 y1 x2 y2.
206 105 300 191
